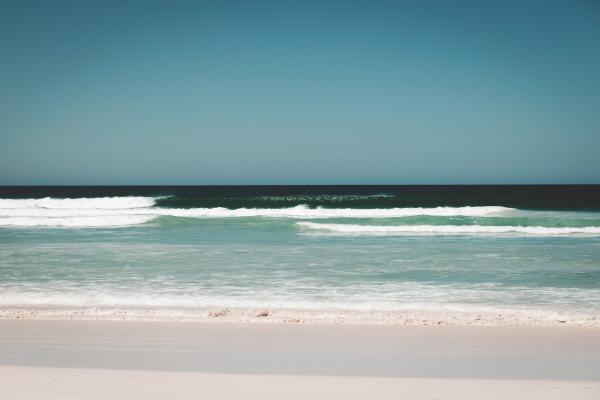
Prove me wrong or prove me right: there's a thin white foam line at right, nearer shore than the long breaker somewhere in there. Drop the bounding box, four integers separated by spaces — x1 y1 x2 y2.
296 222 600 236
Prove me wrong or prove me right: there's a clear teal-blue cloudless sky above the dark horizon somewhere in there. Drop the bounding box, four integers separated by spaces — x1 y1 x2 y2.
0 0 600 185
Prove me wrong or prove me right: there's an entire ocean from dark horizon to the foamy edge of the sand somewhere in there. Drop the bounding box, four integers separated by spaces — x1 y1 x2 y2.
0 185 600 326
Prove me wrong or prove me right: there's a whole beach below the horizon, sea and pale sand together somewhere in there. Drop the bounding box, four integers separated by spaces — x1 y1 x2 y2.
0 186 600 400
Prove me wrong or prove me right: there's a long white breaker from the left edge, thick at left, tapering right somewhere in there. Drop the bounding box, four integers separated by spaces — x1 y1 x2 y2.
0 197 513 227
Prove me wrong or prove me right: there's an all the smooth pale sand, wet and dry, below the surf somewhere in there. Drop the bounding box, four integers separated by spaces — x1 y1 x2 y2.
0 320 600 400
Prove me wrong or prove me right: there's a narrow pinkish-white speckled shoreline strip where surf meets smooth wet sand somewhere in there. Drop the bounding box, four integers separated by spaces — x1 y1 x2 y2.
0 307 600 328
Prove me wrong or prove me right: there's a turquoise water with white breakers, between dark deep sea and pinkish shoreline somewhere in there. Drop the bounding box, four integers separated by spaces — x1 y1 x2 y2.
0 187 600 318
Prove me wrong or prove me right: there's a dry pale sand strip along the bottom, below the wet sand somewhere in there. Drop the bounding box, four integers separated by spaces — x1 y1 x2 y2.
0 366 600 400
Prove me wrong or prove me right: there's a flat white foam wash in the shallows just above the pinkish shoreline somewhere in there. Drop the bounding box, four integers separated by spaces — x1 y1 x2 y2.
0 282 600 312
